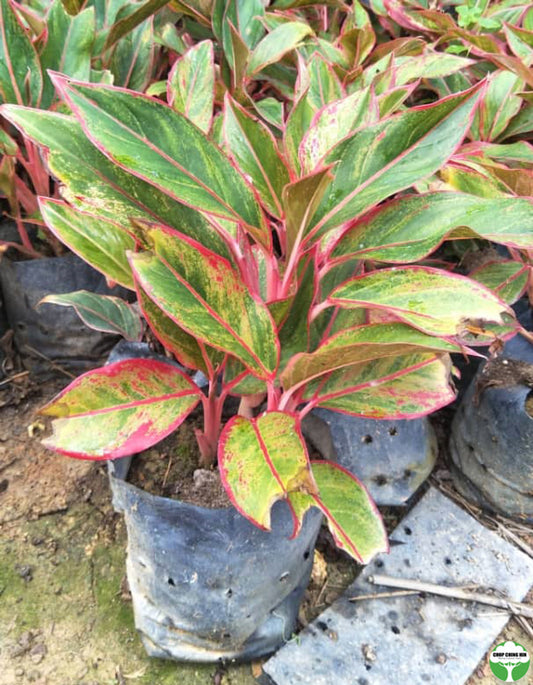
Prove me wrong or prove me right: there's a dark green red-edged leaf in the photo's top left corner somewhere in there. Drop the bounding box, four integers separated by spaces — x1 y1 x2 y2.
0 0 43 106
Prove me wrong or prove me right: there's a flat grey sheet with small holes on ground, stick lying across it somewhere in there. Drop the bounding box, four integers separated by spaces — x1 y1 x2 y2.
263 488 533 685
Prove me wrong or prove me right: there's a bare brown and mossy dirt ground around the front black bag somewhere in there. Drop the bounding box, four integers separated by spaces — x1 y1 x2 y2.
0 376 533 685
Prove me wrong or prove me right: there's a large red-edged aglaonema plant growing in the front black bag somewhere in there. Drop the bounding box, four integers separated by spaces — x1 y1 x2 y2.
2 60 533 562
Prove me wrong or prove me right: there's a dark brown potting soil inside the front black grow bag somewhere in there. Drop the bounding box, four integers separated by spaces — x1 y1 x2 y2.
128 417 231 509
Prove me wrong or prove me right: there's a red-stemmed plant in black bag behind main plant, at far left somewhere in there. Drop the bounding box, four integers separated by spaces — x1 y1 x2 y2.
0 0 165 371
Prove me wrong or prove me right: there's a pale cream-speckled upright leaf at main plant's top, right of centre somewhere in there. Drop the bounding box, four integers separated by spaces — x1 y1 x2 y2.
298 88 379 173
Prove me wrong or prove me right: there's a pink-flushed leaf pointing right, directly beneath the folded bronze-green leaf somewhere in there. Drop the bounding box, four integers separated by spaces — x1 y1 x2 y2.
302 353 455 419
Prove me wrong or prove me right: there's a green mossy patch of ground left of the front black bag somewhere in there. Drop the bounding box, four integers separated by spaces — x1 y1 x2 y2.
0 504 255 685
